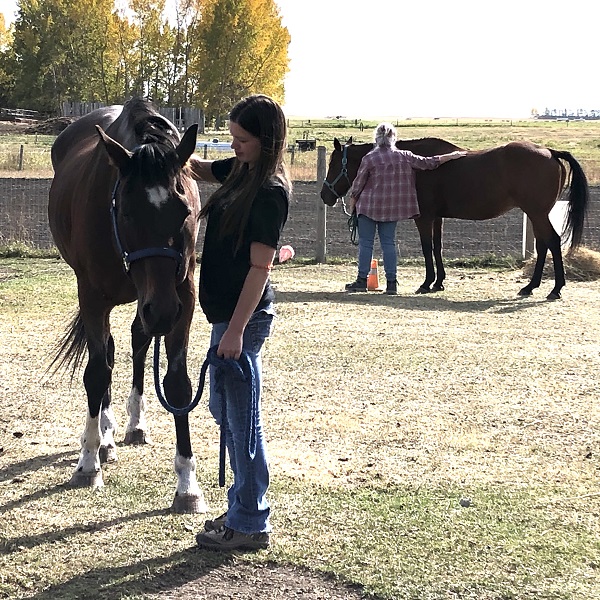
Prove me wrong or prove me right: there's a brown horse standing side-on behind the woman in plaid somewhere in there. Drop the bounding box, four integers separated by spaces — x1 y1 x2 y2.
321 138 589 300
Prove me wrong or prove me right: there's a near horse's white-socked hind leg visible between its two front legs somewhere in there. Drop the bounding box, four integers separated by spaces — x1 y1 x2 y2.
124 313 151 444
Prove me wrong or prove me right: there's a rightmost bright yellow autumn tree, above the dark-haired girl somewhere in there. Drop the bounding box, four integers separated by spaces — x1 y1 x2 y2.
191 0 290 124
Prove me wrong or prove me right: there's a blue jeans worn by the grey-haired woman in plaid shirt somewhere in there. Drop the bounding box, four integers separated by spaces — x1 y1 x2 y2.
358 215 398 281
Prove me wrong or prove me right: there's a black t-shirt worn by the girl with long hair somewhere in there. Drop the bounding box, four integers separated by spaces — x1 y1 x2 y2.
200 158 289 323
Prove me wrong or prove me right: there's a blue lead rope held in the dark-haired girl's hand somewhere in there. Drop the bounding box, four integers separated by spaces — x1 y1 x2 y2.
154 336 258 487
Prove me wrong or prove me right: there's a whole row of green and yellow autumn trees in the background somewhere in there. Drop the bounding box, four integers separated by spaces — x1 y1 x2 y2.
0 0 290 117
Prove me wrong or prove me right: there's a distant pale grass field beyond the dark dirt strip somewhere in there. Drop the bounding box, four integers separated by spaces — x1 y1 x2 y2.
0 119 600 184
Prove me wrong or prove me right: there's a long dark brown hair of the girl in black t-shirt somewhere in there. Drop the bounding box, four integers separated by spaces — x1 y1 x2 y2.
200 94 291 252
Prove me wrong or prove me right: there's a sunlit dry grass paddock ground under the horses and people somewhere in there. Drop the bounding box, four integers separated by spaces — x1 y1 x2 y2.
0 259 600 600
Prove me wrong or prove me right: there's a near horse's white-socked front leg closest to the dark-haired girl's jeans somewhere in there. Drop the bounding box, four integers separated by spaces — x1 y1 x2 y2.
163 298 208 513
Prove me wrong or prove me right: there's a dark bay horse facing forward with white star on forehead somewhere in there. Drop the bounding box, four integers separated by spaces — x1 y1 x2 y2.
48 99 206 512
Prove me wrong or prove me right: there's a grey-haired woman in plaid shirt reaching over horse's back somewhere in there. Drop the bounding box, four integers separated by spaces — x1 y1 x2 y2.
346 123 466 294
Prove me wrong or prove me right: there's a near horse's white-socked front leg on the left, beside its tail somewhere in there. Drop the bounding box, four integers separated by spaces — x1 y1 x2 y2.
70 320 112 487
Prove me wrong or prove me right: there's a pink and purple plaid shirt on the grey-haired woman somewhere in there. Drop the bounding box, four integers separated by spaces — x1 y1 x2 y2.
351 146 441 221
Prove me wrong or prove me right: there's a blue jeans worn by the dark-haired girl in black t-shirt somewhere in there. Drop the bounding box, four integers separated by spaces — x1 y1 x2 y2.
209 306 274 533
